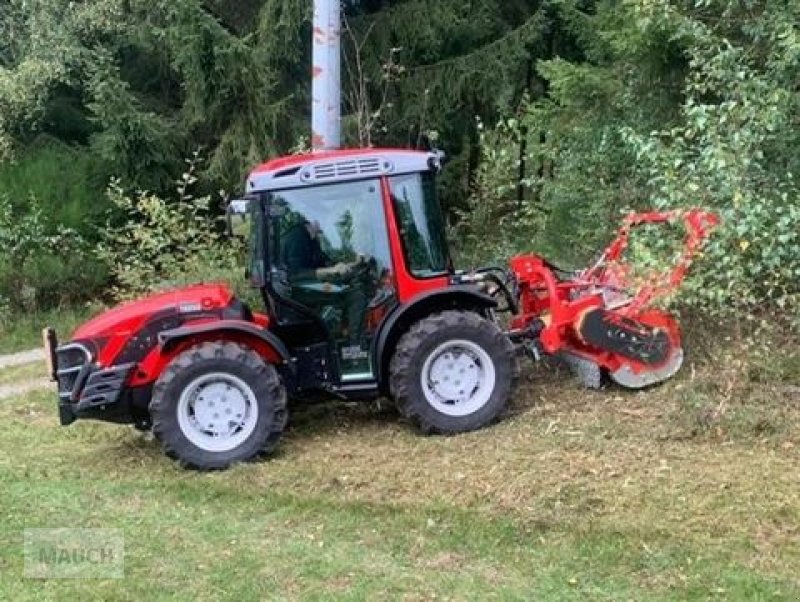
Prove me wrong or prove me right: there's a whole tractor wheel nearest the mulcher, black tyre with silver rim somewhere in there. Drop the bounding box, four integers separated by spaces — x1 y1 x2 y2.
389 311 519 433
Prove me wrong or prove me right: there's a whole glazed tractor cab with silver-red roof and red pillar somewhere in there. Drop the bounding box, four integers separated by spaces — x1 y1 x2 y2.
236 149 452 388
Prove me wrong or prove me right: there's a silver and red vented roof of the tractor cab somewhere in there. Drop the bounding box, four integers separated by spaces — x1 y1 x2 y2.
247 148 441 193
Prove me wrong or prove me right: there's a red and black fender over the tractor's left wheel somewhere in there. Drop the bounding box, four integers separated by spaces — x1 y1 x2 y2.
129 320 291 387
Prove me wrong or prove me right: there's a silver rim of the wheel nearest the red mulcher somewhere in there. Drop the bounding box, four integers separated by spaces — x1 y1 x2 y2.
421 340 496 417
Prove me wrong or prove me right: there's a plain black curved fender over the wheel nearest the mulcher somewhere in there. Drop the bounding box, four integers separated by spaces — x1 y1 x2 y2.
372 284 497 394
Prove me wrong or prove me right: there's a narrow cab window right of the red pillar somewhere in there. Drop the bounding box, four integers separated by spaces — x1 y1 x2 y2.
389 173 450 278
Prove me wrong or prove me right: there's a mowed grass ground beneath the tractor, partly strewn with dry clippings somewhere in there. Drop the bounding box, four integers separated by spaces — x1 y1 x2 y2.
0 354 800 600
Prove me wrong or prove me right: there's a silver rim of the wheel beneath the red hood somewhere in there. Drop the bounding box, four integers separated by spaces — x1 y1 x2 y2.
178 372 258 452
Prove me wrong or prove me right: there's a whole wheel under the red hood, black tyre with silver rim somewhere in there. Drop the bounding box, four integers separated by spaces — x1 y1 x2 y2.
150 341 287 470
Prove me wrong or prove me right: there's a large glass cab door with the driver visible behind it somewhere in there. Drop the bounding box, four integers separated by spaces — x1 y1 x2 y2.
267 179 397 382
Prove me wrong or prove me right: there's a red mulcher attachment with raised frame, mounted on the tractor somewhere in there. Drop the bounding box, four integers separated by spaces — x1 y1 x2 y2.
510 209 719 389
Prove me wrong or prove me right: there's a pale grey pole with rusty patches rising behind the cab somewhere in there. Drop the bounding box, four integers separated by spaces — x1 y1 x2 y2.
311 0 342 151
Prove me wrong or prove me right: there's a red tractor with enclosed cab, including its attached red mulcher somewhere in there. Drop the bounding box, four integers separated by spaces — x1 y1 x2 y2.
45 149 715 469
